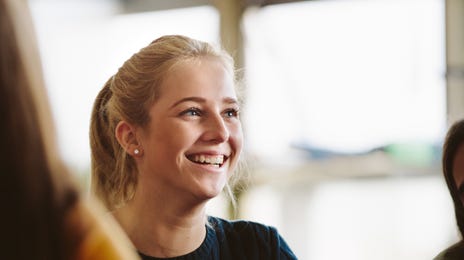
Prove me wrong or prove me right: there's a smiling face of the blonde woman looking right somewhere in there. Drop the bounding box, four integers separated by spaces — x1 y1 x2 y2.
139 58 243 200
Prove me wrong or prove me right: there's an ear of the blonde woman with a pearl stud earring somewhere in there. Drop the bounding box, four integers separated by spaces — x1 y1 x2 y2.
114 121 142 156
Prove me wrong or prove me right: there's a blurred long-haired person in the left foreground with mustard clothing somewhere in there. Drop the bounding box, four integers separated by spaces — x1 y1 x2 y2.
0 0 138 260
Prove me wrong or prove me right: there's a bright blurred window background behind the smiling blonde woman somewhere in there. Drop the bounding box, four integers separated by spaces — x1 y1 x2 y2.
29 0 464 260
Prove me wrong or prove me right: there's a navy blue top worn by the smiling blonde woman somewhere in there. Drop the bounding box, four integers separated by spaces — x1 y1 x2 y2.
139 217 297 260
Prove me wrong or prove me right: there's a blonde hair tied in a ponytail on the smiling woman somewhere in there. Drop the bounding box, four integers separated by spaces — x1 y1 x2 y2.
90 35 243 210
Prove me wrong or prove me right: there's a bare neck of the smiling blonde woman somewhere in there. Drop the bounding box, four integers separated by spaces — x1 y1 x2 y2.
113 187 206 257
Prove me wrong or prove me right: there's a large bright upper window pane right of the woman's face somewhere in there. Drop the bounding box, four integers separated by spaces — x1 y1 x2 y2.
244 0 446 160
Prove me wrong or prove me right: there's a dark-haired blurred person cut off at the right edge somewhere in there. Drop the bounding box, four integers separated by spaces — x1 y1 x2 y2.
435 120 464 259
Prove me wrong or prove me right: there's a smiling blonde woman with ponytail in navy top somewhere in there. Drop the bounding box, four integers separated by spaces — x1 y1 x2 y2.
90 35 296 259
